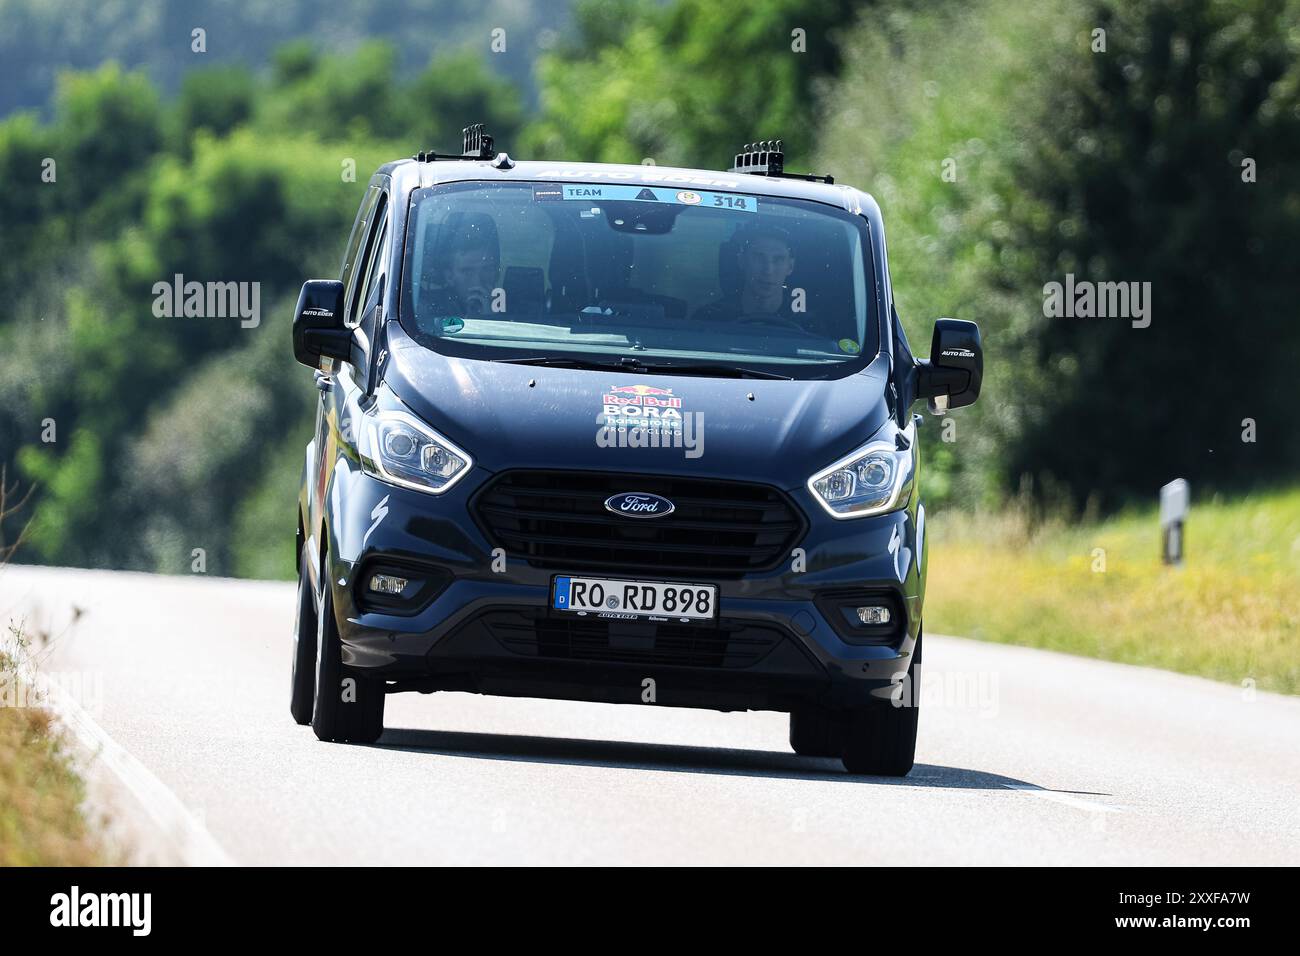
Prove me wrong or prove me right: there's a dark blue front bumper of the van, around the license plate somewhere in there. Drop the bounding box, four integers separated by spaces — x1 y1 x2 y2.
326 459 924 710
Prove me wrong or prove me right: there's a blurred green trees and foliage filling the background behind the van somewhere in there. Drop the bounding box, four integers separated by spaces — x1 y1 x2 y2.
0 0 1300 576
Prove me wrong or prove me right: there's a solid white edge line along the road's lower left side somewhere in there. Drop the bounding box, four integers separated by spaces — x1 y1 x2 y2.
43 684 235 866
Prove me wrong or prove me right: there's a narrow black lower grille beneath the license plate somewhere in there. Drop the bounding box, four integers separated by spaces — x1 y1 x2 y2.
481 609 785 670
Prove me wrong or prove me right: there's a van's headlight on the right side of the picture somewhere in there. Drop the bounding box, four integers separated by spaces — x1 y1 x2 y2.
809 423 917 518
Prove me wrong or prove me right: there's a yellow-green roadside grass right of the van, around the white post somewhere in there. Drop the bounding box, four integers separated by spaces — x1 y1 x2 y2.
926 488 1300 693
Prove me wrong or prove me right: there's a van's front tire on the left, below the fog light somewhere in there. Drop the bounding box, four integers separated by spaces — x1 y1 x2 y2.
312 572 385 744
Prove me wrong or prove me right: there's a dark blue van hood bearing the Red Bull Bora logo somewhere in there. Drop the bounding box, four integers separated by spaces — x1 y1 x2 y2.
384 336 889 490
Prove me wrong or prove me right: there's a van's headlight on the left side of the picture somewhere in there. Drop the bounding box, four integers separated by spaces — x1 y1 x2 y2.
360 411 473 494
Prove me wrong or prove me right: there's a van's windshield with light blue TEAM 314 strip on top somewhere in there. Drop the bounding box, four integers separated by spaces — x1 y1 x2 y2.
402 182 879 378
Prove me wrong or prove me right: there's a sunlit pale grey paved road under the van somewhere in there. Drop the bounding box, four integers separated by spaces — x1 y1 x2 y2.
0 567 1300 864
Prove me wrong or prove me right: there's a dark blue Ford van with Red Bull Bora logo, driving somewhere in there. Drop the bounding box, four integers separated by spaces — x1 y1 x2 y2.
291 127 983 775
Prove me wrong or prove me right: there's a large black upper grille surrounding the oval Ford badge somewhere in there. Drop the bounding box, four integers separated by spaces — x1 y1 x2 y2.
475 471 805 578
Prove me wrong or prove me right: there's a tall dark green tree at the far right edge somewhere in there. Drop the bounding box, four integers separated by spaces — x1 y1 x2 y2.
1008 0 1300 502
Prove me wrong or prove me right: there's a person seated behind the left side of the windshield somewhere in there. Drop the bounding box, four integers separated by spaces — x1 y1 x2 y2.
420 215 501 325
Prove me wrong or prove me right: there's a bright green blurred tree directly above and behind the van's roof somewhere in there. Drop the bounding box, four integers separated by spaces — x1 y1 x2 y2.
525 0 861 168
